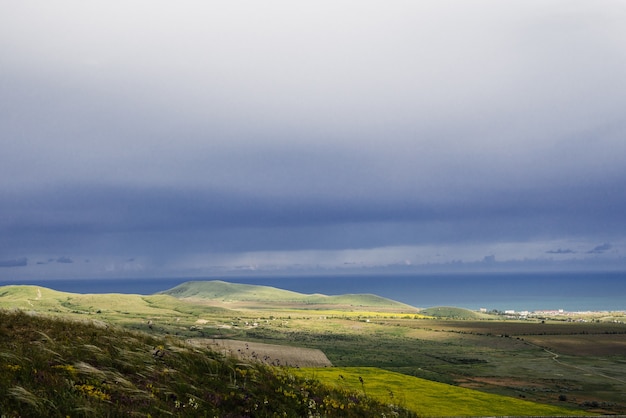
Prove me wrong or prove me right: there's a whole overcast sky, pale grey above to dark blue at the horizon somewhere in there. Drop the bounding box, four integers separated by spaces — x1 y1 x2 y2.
0 0 626 281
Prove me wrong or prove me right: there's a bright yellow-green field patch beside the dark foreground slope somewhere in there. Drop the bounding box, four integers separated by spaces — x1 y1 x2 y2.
295 367 591 416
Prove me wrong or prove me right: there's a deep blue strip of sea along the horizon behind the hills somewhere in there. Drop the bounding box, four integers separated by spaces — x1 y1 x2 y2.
0 272 626 311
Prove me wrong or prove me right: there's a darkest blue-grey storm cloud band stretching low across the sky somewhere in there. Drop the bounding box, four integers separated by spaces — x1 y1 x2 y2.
2 178 626 253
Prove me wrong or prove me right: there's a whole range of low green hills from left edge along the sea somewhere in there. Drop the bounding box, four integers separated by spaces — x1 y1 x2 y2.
0 280 418 317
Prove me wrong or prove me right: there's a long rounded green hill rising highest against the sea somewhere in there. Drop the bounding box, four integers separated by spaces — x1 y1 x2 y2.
159 280 418 312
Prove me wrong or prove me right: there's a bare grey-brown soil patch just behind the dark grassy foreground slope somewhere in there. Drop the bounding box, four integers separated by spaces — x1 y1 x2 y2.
188 338 332 367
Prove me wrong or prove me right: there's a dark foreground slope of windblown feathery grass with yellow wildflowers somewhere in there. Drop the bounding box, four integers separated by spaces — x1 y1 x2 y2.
0 310 414 417
